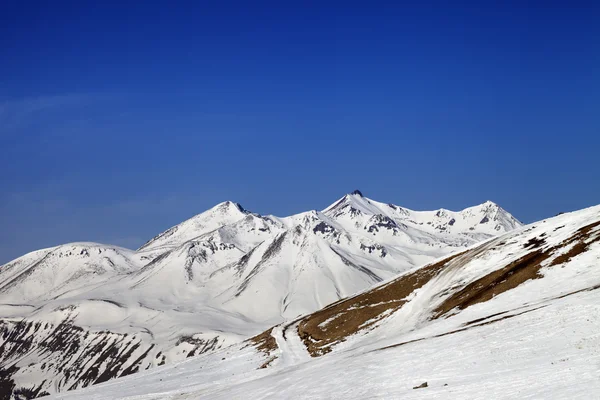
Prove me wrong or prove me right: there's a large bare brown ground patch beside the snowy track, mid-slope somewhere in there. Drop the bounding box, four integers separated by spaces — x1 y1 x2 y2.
298 252 464 357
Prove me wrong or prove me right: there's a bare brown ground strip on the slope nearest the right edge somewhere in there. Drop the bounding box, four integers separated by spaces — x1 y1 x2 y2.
433 221 600 319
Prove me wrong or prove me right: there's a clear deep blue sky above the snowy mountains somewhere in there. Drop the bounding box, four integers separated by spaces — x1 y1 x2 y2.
0 0 600 263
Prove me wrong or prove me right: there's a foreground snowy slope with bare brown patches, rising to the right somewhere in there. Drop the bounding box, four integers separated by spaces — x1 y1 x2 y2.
56 206 600 400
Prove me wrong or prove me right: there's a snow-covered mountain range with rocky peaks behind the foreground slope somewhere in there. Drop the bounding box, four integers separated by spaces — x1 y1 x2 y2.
0 192 521 398
